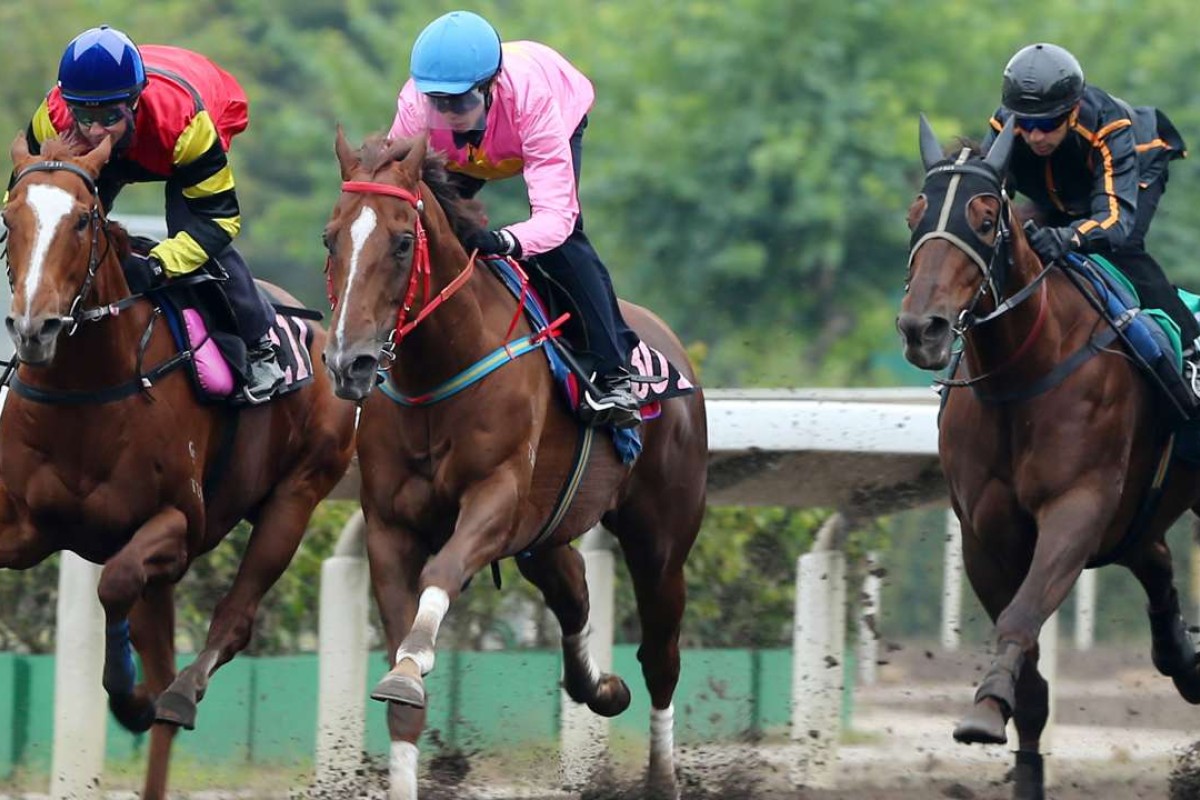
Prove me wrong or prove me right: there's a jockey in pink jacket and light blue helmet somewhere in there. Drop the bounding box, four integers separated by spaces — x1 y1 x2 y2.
389 11 641 427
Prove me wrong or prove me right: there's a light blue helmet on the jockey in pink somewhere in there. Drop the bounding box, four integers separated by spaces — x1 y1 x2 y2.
409 11 500 95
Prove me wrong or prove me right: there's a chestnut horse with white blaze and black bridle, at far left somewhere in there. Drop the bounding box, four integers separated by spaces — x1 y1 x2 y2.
0 134 354 799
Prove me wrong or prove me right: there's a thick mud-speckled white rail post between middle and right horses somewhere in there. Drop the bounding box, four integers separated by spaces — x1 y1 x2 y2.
791 513 847 788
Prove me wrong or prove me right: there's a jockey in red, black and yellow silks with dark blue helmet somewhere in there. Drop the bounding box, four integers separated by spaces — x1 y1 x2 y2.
10 25 284 403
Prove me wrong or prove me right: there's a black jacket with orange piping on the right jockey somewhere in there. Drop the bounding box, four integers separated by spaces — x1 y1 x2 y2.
983 86 1187 251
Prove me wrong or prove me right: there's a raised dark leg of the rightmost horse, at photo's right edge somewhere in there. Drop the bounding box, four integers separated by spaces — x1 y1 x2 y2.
1128 540 1200 704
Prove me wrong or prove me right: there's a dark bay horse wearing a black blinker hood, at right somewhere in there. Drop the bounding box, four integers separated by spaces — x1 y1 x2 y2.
896 118 1200 800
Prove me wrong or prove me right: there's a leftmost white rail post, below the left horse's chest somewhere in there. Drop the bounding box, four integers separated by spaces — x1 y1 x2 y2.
50 552 108 800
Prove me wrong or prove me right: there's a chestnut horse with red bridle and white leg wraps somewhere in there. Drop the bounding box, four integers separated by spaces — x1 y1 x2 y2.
324 130 708 800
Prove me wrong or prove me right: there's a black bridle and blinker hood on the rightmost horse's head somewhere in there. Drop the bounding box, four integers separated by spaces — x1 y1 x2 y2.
905 149 1052 386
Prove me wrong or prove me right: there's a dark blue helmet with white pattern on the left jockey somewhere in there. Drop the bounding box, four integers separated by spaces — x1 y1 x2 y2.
59 25 146 106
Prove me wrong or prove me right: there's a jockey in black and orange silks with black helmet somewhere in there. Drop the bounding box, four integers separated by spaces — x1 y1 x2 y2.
983 43 1200 350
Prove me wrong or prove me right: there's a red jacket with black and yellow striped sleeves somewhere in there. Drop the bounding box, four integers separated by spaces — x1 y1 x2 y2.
19 44 248 276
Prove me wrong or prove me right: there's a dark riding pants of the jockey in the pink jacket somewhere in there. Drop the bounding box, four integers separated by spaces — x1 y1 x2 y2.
452 116 638 375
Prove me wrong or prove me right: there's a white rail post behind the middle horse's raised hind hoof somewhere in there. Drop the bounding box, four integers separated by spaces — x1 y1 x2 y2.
559 525 614 787
